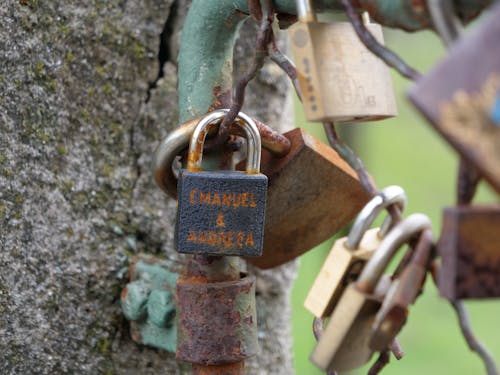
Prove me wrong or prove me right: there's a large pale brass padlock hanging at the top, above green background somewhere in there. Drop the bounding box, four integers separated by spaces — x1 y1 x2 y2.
290 0 397 123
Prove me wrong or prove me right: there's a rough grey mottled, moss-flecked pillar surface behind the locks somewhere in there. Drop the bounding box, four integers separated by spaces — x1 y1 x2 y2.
0 0 295 374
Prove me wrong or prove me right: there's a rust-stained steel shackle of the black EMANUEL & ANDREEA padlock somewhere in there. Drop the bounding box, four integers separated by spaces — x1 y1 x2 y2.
186 109 262 174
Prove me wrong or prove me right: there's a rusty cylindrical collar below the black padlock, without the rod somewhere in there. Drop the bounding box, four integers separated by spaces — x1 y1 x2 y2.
177 275 258 366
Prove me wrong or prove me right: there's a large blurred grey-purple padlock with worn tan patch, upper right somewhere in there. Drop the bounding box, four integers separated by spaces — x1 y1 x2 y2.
409 3 500 197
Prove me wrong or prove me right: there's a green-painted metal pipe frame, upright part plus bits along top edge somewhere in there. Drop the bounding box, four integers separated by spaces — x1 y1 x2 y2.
179 0 492 123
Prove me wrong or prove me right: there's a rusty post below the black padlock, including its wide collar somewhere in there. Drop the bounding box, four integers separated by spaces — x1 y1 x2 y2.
176 255 257 375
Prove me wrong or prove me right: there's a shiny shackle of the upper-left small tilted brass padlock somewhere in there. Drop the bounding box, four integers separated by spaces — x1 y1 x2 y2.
345 185 407 250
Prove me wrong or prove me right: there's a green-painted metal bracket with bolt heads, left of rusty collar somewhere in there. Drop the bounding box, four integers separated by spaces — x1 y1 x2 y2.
121 257 178 352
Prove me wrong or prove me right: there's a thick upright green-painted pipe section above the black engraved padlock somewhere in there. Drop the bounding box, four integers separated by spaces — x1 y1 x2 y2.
179 0 247 123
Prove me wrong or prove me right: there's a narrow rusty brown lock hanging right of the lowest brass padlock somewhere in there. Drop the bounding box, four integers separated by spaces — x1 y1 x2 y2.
369 229 433 351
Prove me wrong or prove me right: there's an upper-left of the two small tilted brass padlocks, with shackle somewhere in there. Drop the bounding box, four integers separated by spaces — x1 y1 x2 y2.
304 186 406 318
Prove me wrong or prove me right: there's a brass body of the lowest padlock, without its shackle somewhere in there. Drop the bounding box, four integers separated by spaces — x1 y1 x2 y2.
310 284 380 372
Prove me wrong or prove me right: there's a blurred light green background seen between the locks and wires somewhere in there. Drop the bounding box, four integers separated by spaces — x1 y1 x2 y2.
292 25 500 375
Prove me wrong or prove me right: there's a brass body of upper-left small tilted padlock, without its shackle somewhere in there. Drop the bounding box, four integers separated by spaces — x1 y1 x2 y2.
304 228 381 318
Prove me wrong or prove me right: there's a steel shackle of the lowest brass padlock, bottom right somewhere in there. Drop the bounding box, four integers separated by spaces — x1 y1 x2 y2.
356 214 432 293
